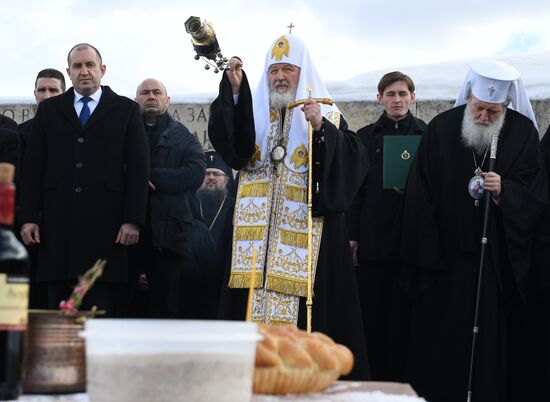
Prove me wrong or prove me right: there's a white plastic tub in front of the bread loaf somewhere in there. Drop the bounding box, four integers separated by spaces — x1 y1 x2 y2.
81 319 261 402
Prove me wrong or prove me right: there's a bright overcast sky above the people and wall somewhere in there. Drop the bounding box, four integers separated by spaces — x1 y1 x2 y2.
0 0 550 99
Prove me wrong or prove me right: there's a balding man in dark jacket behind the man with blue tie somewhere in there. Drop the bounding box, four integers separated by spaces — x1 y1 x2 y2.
136 78 206 318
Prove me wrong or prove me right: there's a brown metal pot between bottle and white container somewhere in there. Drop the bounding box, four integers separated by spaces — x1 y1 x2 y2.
23 310 86 394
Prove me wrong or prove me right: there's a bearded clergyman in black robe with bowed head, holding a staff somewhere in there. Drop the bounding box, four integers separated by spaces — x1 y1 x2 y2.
401 61 547 402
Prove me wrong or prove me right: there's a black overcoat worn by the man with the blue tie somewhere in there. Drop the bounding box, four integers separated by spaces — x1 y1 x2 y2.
19 86 150 283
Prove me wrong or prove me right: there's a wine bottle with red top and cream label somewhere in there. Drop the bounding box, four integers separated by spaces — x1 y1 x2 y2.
0 163 29 400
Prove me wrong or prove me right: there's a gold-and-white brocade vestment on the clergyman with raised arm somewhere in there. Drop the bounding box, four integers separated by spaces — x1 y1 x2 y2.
229 110 340 324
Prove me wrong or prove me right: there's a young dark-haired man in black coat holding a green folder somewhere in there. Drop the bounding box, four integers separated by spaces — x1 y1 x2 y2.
346 71 426 381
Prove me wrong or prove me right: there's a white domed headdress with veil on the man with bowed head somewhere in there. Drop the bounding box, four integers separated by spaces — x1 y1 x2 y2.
455 60 537 127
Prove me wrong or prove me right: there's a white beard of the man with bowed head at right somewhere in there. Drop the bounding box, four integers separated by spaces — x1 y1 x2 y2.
462 102 506 155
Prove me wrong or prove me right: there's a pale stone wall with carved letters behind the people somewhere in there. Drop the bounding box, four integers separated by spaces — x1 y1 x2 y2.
0 99 550 149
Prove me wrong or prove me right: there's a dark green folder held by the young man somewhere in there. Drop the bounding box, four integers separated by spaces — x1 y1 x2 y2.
382 135 420 190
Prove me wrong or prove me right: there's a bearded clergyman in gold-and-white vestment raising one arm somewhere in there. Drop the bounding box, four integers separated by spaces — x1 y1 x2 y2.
208 34 368 379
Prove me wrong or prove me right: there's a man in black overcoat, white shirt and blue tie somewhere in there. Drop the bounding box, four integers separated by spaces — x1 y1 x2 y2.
20 43 150 316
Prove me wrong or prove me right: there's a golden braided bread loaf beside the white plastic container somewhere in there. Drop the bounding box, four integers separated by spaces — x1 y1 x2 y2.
253 324 353 394
